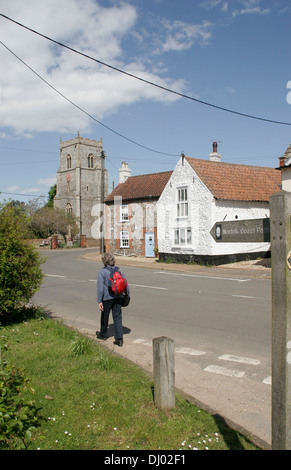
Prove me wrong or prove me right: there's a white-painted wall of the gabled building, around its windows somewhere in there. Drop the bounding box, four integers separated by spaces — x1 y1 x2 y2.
157 157 270 255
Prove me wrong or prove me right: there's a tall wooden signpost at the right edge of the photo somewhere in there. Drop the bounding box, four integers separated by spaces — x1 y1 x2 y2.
270 191 291 450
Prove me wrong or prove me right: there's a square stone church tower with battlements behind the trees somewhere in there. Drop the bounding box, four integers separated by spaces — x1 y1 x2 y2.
54 132 108 238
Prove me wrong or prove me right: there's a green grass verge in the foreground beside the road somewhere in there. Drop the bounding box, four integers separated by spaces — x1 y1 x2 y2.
0 308 259 451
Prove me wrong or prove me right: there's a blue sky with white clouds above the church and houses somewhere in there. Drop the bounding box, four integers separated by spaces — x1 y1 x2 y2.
0 0 291 202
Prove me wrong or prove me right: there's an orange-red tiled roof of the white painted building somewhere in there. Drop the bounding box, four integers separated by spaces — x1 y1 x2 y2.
185 157 282 201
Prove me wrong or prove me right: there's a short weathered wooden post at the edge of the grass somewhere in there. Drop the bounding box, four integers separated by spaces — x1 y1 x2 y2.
153 336 175 409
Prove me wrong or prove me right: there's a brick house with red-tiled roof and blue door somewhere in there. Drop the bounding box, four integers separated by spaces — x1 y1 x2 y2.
105 162 172 257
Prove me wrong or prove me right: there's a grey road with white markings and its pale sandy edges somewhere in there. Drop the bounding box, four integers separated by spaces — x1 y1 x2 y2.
33 249 271 448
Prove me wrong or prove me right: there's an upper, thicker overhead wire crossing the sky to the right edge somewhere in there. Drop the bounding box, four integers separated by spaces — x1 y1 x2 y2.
0 13 291 126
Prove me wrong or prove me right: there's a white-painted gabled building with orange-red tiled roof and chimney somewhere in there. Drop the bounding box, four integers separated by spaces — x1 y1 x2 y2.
157 143 281 264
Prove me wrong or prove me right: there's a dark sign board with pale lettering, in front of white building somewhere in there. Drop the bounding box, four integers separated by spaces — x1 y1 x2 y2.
210 218 271 243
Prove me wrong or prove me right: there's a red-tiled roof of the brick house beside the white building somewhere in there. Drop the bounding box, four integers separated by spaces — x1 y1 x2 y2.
105 171 172 203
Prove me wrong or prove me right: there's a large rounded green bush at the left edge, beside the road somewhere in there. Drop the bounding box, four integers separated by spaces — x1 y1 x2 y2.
0 204 43 322
